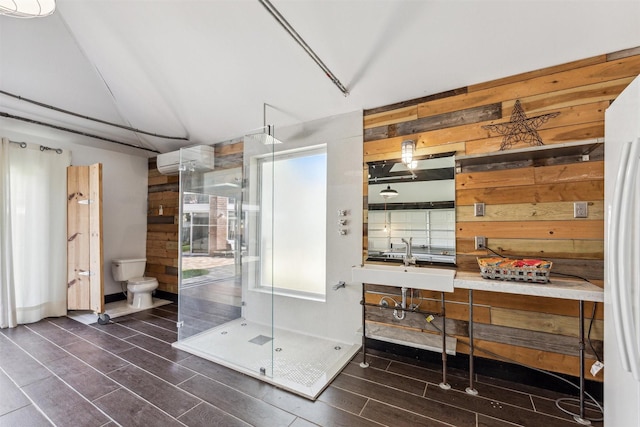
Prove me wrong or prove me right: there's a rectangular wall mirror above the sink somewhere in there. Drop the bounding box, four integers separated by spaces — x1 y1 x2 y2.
367 152 456 264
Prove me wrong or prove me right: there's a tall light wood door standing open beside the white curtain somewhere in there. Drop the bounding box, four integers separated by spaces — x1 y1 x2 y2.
67 163 104 313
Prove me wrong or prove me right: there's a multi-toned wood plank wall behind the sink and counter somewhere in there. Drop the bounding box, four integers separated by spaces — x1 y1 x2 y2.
363 48 640 381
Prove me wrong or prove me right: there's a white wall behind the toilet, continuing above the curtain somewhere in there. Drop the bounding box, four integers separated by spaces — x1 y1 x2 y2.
0 129 148 295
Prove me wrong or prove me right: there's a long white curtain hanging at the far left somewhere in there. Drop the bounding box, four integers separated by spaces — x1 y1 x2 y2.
0 139 71 328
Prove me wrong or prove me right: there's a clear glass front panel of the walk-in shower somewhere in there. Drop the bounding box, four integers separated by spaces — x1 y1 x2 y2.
174 130 274 377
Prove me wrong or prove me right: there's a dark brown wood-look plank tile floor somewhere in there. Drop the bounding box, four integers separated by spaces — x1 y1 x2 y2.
0 304 601 427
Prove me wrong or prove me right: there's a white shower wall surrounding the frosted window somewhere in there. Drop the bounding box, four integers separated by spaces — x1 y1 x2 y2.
243 111 363 343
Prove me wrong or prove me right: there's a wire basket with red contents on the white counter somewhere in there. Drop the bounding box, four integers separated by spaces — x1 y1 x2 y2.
478 258 553 283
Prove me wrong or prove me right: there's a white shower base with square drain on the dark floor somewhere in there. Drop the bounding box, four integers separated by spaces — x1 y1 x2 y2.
173 319 360 399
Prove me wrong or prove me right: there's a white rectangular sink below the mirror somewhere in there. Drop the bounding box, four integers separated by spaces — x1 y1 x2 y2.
351 264 456 292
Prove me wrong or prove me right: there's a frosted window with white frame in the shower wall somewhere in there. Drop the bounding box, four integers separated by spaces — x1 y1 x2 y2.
259 145 327 299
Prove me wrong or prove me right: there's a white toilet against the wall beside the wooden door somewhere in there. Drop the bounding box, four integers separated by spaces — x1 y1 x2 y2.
111 258 158 308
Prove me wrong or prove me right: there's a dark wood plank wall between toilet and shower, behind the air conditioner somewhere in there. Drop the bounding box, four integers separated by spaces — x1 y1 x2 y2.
145 141 243 294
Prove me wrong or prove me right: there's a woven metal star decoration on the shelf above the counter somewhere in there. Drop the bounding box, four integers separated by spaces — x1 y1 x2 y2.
482 99 560 150
